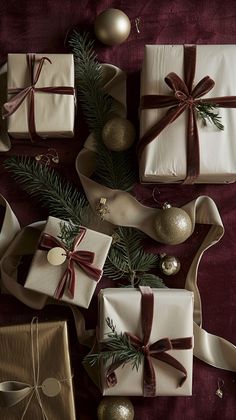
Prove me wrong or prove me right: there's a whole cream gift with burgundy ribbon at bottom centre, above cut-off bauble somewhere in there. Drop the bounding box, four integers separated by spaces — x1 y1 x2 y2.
99 287 193 397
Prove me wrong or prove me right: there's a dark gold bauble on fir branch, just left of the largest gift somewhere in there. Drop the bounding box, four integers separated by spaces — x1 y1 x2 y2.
102 117 135 152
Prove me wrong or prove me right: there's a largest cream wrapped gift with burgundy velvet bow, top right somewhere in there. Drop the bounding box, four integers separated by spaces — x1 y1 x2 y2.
139 45 236 183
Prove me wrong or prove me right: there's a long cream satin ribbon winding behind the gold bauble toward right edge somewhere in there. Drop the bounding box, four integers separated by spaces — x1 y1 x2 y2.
76 65 236 371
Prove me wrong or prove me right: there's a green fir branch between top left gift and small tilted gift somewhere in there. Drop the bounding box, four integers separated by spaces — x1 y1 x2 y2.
4 156 86 225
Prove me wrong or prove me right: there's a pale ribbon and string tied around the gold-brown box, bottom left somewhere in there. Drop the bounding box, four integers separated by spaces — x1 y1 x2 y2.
0 317 49 420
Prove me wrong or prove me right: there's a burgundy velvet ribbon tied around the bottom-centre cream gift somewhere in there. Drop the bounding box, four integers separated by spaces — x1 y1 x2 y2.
106 286 192 397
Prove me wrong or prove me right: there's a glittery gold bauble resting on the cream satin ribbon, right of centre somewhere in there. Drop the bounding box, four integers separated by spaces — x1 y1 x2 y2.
154 203 192 245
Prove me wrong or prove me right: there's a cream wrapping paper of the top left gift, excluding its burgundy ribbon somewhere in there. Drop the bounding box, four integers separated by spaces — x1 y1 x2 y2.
4 54 75 138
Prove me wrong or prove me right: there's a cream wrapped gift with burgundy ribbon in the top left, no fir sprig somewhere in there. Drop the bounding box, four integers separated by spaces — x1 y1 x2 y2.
3 54 75 141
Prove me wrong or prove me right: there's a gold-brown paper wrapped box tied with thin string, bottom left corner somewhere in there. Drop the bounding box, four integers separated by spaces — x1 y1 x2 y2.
0 319 76 420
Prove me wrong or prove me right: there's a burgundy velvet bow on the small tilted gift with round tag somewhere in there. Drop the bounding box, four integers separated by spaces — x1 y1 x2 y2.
39 228 102 299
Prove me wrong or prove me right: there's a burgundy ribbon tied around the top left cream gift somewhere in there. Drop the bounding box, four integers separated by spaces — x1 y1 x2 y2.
2 54 74 142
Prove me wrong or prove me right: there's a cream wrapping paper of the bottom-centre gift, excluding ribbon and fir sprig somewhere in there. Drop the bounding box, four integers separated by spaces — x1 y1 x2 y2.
99 288 193 396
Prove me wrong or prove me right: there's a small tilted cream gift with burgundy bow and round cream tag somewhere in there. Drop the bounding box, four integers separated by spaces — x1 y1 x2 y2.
25 217 112 308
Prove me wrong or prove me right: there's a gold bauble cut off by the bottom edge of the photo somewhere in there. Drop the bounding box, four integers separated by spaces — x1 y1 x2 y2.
97 397 134 420
